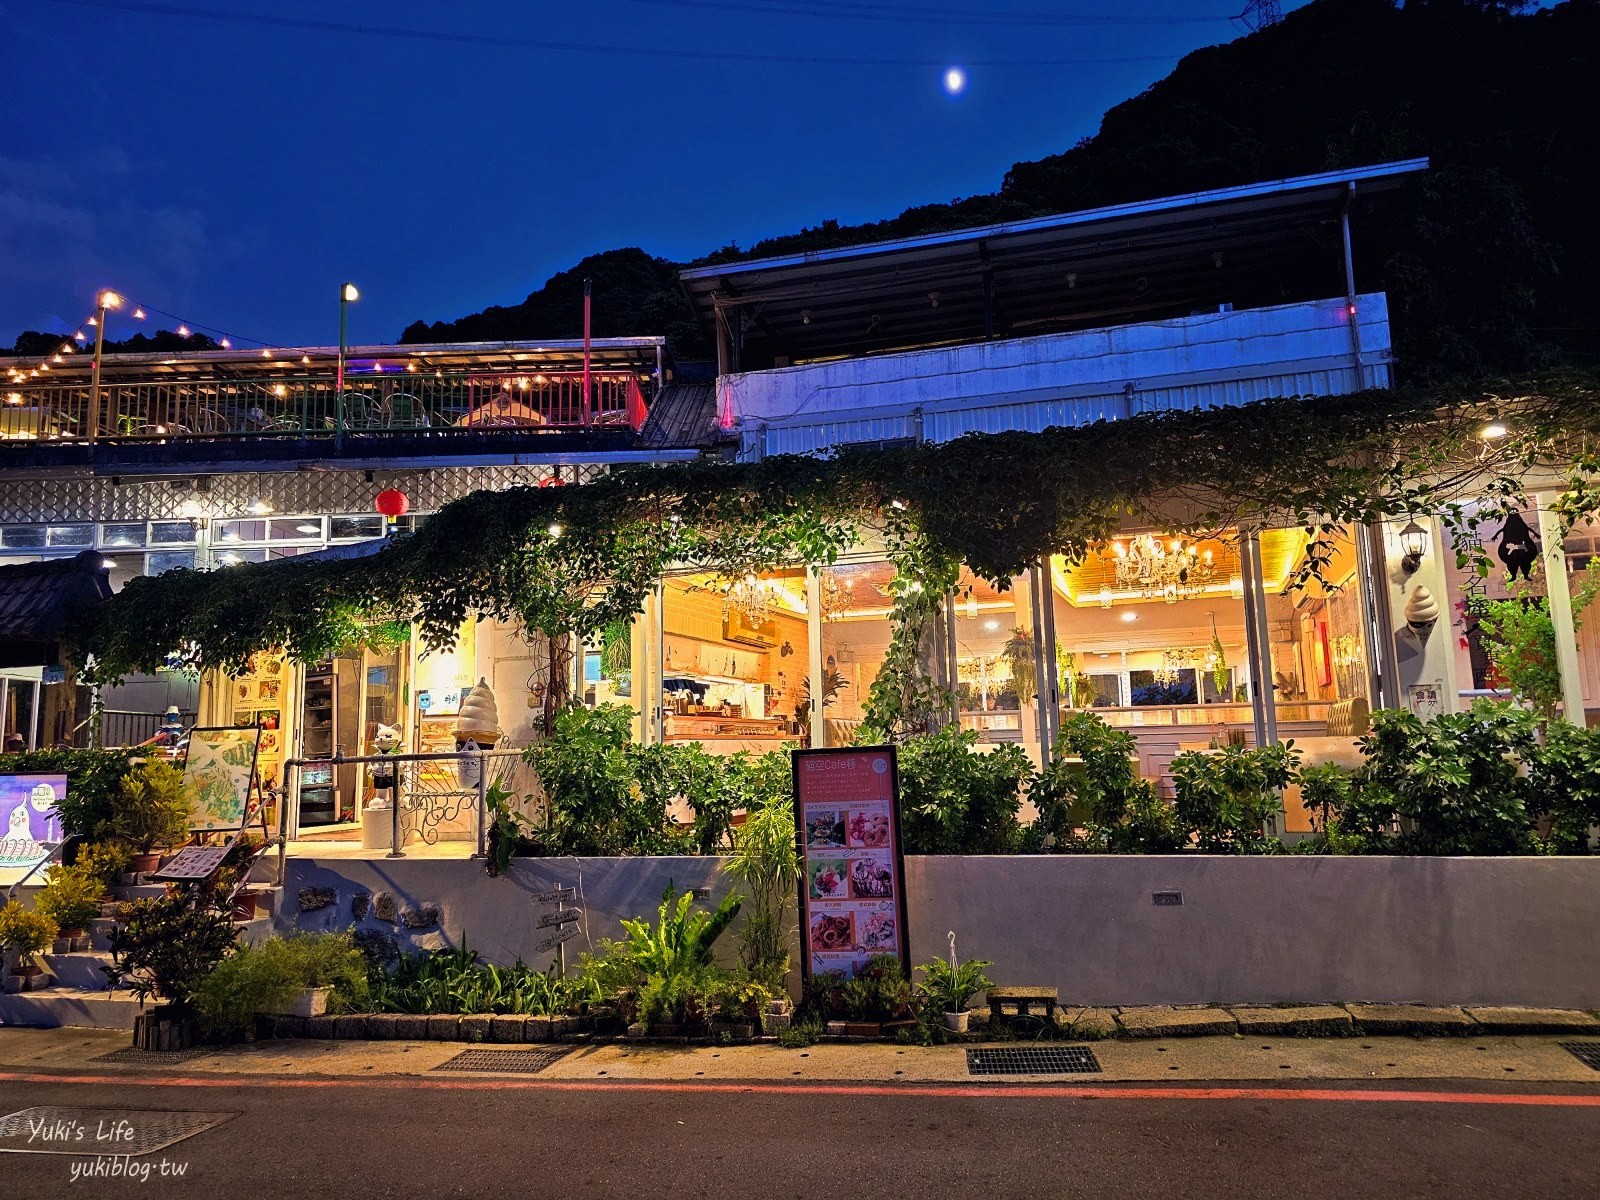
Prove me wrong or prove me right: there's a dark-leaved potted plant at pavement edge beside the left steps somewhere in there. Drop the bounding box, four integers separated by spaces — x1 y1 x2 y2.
106 896 237 1050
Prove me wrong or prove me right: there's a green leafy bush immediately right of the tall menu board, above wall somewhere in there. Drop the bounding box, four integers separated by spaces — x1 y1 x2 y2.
899 725 1032 854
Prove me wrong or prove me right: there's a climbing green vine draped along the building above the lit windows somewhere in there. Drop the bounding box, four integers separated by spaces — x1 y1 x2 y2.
74 376 1600 731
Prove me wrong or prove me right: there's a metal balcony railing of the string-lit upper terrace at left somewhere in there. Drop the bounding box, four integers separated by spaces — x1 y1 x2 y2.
0 371 646 442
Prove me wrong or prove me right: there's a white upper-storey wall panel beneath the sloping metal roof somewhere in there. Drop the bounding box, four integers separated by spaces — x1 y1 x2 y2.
717 293 1390 456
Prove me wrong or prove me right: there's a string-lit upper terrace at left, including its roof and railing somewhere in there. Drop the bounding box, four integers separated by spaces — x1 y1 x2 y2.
0 338 662 470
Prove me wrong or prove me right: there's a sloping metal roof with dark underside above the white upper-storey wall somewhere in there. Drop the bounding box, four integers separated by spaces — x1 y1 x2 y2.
680 158 1427 370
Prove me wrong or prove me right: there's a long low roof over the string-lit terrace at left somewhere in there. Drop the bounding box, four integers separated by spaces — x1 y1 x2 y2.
0 338 666 384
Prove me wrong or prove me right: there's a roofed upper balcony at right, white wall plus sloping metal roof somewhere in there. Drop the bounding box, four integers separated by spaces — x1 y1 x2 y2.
682 158 1427 458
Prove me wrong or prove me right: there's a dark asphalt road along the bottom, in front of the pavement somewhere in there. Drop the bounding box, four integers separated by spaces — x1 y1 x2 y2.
0 1077 1600 1200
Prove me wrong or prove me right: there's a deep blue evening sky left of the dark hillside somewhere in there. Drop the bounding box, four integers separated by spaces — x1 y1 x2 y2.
0 0 1298 347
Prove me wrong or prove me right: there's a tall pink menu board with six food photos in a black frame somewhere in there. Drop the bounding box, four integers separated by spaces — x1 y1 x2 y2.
794 746 910 979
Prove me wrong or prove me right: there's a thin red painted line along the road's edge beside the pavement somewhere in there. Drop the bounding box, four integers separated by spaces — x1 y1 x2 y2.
0 1072 1600 1109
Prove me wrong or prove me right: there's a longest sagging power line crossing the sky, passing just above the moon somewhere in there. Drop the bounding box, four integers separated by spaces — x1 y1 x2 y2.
53 0 1173 69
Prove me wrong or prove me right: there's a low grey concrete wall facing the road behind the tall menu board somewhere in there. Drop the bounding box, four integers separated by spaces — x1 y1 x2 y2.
277 854 1600 1008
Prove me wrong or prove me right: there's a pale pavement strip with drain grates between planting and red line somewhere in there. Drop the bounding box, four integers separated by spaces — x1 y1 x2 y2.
0 1029 1600 1088
